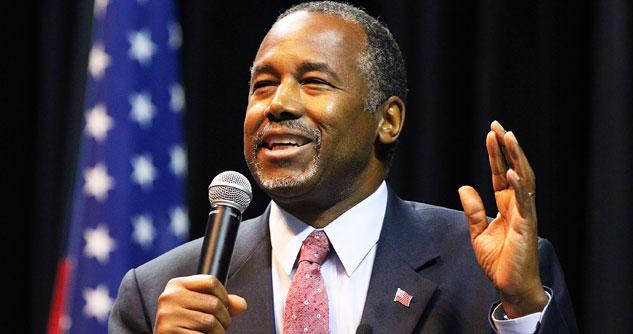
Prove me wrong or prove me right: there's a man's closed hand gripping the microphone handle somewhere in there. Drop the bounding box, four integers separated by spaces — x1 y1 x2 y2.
154 275 246 333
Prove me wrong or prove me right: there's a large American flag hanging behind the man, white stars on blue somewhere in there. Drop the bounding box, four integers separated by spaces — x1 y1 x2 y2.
48 0 189 334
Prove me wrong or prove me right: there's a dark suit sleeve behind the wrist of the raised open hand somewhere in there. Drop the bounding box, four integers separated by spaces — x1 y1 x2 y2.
537 239 578 334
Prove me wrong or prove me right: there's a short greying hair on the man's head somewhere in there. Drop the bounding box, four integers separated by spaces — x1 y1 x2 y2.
277 1 407 113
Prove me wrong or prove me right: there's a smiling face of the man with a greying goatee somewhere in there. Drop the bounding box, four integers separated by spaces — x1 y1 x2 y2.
244 12 378 201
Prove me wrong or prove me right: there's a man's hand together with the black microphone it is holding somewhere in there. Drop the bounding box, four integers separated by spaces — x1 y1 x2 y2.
154 171 253 333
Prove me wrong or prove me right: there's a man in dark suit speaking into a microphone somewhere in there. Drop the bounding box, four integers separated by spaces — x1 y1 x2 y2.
110 2 576 333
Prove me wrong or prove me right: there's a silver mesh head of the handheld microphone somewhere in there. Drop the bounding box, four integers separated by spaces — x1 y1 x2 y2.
209 171 253 213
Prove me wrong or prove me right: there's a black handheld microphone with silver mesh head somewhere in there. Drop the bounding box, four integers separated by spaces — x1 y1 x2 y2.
198 171 253 284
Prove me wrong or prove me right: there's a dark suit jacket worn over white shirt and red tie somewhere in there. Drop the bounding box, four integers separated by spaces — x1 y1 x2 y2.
109 189 578 333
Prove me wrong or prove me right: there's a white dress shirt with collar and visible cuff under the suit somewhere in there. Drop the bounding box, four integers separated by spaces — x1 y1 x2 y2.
269 181 549 334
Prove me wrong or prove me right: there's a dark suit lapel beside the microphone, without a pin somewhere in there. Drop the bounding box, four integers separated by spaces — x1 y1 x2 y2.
226 209 275 333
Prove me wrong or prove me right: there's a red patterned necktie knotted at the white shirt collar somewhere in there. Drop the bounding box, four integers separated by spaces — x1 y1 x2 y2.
284 231 330 334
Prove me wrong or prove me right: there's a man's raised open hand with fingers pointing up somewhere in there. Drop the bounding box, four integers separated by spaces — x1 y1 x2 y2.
459 121 547 318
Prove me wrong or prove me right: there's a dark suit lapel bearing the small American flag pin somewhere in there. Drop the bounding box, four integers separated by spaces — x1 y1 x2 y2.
357 189 439 333
